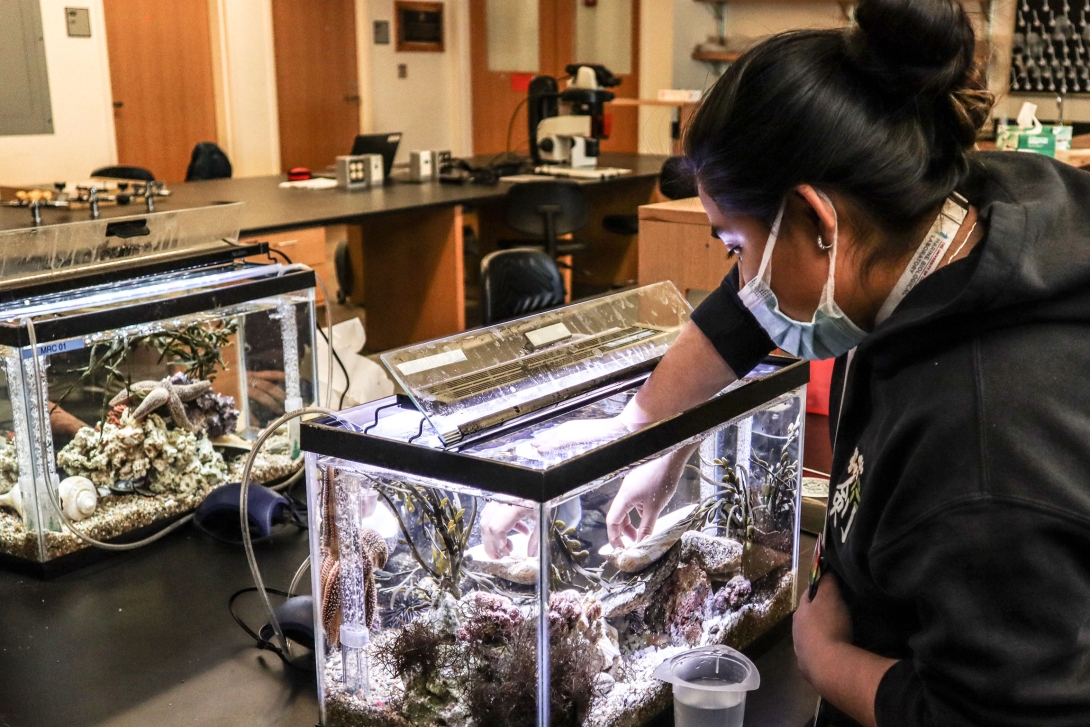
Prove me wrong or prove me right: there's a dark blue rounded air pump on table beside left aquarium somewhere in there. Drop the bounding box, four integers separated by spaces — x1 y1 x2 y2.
193 483 302 543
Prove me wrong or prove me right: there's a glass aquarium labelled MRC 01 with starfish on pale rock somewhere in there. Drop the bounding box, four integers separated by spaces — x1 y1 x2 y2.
0 204 315 574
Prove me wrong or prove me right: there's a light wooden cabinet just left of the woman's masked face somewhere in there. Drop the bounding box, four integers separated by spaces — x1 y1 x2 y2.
639 197 737 296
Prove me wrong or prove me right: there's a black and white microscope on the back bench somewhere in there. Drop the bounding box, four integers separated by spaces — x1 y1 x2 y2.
528 64 620 169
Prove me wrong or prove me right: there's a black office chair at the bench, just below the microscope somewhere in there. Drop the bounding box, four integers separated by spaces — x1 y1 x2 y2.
499 181 590 259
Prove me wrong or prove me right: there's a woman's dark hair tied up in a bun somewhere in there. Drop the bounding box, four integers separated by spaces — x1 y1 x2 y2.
686 0 992 256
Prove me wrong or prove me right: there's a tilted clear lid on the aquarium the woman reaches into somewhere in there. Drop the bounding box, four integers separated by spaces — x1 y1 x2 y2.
382 282 692 447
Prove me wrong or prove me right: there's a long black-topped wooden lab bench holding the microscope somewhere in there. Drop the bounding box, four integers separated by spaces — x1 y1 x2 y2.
0 154 665 351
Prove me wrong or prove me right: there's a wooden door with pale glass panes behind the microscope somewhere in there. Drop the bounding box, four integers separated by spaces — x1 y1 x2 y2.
470 0 640 154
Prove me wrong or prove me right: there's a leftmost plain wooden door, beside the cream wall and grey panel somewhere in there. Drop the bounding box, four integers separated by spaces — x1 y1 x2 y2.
103 0 217 182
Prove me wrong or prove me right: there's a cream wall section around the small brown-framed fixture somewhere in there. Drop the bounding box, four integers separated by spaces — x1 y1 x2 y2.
359 0 473 161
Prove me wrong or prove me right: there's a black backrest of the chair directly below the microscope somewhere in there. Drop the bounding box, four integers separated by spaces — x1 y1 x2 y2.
504 181 590 240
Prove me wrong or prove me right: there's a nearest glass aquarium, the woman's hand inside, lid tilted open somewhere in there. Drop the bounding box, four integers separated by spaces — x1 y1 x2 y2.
302 282 809 727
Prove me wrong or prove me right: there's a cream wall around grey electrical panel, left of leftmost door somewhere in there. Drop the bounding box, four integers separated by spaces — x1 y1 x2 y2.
0 0 118 184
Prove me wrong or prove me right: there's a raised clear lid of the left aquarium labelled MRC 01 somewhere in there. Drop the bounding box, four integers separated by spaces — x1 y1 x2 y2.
0 202 243 301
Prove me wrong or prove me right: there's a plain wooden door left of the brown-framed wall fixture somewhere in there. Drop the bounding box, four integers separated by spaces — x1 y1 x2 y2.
273 0 360 171
